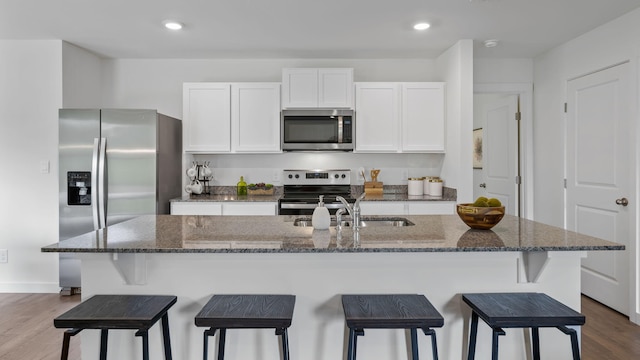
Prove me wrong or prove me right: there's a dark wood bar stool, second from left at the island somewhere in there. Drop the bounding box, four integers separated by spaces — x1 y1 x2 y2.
195 295 296 360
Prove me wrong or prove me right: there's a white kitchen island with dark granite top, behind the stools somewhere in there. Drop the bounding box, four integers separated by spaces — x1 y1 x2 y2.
42 215 624 360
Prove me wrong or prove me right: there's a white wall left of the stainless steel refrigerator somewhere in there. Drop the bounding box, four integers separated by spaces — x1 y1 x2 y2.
0 40 62 292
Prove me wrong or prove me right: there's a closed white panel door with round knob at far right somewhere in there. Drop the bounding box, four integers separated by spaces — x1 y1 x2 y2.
566 64 631 314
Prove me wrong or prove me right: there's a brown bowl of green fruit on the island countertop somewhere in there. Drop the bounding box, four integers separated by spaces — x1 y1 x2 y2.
457 196 504 230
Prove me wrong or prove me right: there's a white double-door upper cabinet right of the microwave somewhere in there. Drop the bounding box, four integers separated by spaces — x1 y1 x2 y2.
355 82 445 152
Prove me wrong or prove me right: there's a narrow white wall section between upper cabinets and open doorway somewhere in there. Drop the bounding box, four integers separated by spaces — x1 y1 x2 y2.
437 40 473 202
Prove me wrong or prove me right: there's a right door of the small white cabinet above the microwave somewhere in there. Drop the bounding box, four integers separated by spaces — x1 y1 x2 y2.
318 68 353 109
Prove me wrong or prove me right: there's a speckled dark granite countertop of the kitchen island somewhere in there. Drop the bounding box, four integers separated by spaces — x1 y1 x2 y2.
42 215 624 253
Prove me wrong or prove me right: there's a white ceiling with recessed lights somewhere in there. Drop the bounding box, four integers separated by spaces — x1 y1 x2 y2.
0 0 640 59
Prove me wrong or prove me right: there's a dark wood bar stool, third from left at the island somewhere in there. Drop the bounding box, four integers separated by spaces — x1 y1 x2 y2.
342 294 444 360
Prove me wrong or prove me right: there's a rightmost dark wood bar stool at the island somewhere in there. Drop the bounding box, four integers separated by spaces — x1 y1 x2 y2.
462 293 585 360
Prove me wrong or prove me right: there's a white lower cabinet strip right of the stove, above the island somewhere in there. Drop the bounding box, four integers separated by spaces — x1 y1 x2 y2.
360 201 455 215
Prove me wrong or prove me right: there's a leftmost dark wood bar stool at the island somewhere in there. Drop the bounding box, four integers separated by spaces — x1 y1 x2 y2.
53 295 177 360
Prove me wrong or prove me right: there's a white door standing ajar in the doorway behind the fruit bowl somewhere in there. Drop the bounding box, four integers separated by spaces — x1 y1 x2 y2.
482 95 519 216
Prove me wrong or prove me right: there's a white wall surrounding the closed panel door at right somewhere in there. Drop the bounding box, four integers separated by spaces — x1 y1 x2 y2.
534 9 640 322
